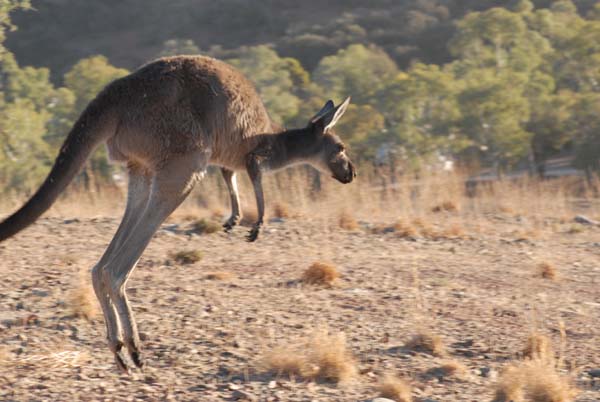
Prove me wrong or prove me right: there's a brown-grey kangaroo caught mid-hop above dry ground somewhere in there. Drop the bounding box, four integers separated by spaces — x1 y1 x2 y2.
0 56 356 372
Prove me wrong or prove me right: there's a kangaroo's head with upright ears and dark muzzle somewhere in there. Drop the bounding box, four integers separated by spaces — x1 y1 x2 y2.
307 97 356 184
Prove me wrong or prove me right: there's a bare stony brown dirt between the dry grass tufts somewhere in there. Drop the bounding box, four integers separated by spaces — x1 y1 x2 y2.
0 214 600 402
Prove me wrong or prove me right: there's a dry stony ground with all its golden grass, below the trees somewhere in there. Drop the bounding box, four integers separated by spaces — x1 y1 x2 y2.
0 170 600 402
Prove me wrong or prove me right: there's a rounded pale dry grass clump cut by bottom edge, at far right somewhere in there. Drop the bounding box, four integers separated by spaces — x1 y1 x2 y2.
494 360 577 402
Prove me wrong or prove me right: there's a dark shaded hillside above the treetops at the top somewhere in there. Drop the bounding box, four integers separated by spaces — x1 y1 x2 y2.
7 0 594 82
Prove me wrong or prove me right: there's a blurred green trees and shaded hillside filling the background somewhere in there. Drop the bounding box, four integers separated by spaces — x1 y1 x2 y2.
0 0 600 195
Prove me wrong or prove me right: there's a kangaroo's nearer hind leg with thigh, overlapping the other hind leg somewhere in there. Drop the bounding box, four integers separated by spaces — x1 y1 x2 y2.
103 154 208 367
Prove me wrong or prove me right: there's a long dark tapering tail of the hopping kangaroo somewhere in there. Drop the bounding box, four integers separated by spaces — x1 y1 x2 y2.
0 96 116 242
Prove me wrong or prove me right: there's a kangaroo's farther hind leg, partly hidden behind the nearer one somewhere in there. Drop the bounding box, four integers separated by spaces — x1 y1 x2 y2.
92 165 150 371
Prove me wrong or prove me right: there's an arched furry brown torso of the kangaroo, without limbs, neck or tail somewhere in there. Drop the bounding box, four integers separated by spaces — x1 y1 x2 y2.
108 56 271 168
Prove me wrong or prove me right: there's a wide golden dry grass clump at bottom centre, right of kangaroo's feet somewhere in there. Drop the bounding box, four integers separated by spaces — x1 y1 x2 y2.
263 329 358 383
